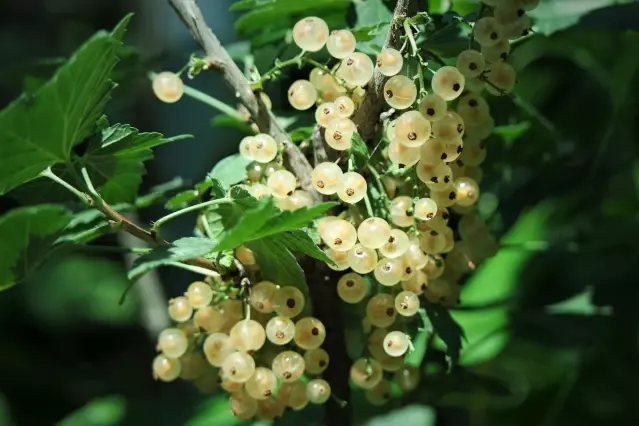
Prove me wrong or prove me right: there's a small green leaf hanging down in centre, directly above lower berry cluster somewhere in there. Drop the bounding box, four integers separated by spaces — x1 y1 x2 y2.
246 235 307 293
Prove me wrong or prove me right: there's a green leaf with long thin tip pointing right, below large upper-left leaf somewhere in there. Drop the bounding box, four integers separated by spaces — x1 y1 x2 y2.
80 124 191 203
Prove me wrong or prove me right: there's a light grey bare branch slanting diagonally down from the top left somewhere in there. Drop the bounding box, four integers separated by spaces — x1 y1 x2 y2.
169 0 321 201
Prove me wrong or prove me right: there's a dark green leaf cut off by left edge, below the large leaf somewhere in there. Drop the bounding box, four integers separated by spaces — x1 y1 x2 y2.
0 204 72 290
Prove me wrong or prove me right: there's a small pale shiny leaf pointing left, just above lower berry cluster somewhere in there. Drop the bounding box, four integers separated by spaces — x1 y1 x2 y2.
128 237 215 280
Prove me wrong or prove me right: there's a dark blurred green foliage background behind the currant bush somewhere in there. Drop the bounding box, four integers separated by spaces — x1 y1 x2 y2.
0 0 639 426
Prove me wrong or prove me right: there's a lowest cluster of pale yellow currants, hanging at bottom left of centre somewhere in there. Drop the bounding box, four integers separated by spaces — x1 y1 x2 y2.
153 278 331 421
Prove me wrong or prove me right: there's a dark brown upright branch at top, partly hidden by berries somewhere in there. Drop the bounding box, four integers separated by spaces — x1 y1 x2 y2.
353 0 420 141
